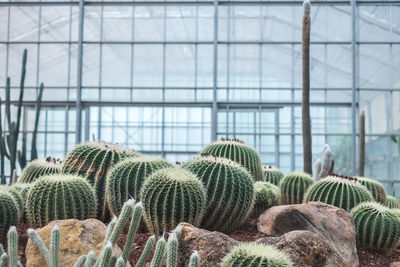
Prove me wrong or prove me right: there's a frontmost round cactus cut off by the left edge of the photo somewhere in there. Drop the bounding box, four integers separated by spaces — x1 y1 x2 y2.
0 190 19 244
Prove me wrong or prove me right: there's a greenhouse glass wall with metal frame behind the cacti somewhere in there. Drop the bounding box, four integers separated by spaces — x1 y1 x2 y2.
0 0 400 194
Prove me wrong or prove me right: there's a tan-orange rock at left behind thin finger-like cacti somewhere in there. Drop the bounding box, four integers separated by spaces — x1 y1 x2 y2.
25 219 128 267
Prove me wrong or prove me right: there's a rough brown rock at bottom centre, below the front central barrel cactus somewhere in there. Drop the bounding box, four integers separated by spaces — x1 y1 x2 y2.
178 223 239 266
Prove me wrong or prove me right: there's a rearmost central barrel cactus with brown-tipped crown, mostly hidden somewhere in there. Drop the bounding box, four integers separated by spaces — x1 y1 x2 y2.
202 139 264 181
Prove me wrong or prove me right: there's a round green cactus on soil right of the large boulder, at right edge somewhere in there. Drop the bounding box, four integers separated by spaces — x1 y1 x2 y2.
350 202 400 254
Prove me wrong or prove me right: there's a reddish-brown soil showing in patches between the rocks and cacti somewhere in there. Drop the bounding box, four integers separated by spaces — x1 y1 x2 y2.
12 222 400 267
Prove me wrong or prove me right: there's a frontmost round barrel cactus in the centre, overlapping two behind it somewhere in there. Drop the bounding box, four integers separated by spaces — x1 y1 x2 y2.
141 168 206 235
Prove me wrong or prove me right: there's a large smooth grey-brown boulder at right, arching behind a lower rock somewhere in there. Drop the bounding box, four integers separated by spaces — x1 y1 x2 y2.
257 202 359 266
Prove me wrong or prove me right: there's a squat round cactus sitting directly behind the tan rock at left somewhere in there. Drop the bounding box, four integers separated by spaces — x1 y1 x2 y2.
26 174 96 227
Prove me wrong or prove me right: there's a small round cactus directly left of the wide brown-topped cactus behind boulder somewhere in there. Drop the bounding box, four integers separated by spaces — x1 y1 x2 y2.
279 172 314 205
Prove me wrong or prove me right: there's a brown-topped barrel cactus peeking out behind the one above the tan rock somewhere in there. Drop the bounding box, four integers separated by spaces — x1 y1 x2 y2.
18 157 61 183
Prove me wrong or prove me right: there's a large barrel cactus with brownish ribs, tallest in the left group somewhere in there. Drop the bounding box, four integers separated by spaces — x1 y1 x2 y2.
61 141 138 222
